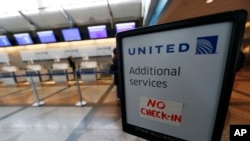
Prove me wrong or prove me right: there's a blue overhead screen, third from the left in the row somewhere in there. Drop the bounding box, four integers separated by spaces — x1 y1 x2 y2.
37 30 56 43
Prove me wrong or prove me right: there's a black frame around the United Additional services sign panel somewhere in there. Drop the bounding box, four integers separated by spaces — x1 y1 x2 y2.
116 10 247 141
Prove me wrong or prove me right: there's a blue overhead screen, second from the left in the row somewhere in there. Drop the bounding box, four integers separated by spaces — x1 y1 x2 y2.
14 33 33 45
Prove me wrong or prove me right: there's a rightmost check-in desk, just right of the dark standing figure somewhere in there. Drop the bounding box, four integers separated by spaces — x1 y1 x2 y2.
80 61 98 82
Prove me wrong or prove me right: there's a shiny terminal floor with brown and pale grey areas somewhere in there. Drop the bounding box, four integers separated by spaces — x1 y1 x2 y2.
0 68 250 141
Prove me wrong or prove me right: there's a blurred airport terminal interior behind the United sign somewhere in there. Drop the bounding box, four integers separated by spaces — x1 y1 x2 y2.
0 0 250 141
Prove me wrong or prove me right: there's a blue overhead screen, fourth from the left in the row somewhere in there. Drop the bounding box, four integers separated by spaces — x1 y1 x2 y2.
62 28 81 41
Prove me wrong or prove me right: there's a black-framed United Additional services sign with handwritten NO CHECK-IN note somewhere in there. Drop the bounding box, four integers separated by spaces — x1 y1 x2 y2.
116 10 247 141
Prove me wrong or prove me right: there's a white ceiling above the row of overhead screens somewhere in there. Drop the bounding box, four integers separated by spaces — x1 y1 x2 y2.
0 0 142 34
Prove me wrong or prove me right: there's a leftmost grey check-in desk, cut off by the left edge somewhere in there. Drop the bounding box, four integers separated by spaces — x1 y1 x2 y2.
0 71 16 86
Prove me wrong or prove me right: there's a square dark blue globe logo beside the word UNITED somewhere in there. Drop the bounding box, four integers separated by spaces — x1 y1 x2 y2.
195 36 218 55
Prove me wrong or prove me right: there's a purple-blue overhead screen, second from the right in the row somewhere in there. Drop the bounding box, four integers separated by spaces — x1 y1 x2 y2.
88 25 108 39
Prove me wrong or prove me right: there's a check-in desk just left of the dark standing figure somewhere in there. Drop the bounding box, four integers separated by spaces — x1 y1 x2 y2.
51 63 68 83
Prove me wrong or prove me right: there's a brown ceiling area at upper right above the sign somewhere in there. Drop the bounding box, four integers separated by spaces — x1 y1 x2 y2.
158 0 250 40
